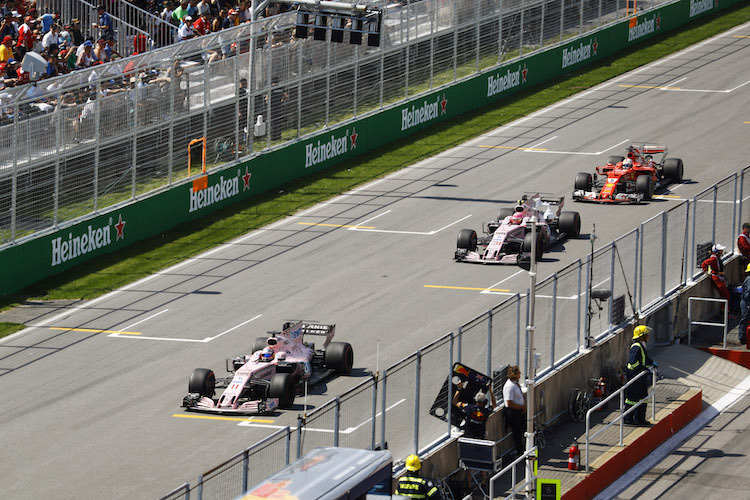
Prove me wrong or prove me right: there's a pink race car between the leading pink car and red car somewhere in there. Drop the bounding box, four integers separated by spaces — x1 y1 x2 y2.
453 194 581 264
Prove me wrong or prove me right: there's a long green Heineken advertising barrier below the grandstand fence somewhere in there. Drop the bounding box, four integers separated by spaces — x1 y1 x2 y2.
0 0 746 295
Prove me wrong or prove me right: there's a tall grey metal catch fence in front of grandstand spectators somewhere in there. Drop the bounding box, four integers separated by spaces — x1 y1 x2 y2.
0 0 665 246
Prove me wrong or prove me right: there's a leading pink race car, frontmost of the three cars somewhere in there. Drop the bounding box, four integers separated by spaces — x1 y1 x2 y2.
182 321 354 415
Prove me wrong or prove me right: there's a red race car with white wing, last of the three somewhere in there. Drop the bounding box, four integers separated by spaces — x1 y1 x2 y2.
573 144 683 203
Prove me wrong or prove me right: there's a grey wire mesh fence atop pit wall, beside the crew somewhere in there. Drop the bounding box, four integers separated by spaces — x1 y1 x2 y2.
165 167 750 500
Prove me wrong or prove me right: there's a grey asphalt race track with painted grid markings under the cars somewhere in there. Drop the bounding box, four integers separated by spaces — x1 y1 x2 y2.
0 24 750 499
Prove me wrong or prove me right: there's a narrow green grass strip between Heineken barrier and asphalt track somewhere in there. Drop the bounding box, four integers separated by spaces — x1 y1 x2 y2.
0 5 750 309
